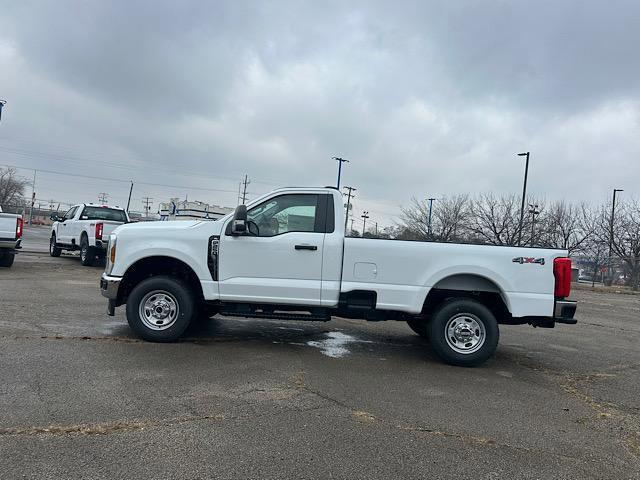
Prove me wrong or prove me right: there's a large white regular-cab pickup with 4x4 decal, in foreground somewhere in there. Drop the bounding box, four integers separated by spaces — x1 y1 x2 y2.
100 188 576 366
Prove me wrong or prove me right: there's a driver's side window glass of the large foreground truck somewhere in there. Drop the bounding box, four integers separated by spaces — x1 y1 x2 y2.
247 194 318 237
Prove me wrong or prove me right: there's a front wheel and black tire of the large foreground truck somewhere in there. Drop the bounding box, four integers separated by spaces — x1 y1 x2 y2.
126 276 197 342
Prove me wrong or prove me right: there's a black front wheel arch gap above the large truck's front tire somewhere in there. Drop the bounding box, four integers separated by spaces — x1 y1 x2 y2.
116 255 204 305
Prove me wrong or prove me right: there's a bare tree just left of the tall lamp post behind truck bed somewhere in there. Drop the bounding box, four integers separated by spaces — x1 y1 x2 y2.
468 193 529 245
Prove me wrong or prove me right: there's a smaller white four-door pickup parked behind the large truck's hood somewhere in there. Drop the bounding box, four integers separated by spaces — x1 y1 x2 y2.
49 203 129 266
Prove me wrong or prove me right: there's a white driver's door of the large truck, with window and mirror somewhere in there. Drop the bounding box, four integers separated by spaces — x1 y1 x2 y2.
219 193 331 305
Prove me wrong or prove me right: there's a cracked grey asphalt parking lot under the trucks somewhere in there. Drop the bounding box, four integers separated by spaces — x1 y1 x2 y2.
0 229 640 479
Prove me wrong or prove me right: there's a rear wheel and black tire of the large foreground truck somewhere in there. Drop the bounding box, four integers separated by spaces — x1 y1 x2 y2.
429 298 500 367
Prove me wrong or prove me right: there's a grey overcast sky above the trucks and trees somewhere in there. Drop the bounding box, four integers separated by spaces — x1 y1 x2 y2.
0 0 640 224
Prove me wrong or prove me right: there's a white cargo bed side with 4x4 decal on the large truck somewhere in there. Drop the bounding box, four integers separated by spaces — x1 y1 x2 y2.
340 238 567 317
